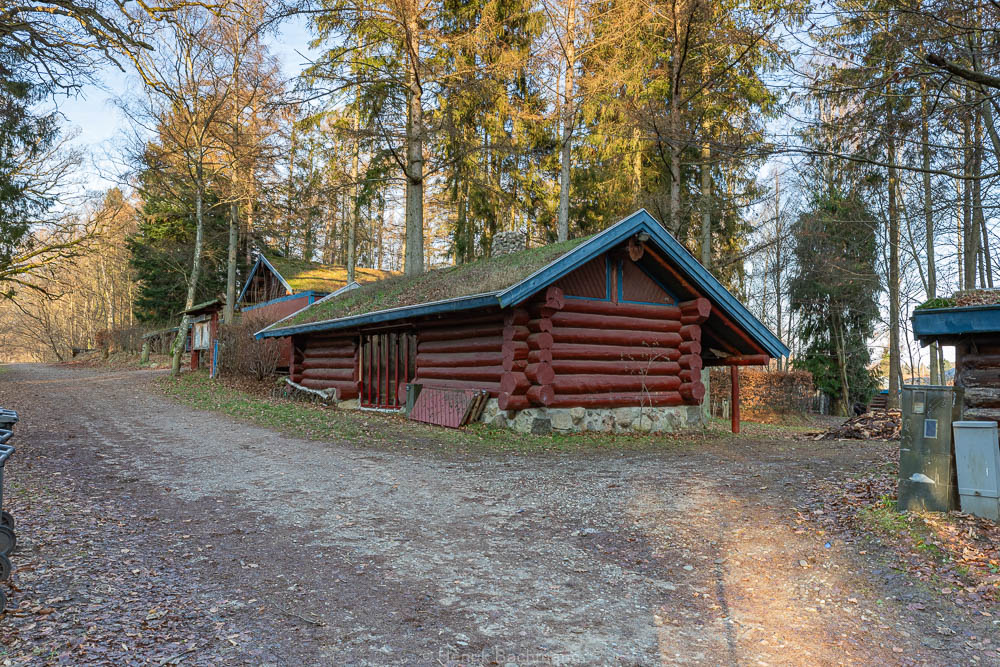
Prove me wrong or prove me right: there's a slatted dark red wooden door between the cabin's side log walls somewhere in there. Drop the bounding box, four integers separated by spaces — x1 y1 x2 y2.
361 331 417 409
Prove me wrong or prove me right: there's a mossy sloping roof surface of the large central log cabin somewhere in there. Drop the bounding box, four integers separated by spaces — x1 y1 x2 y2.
275 237 589 328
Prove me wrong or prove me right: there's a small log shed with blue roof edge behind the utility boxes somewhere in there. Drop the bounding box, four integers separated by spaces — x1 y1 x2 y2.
911 302 1000 422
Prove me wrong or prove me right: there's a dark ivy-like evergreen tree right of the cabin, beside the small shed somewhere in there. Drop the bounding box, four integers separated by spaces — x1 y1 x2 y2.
789 187 879 416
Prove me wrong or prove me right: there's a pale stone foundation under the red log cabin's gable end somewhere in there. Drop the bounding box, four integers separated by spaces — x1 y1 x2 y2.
481 398 704 435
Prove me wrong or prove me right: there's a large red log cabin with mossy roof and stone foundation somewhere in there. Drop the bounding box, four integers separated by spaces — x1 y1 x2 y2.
257 210 788 431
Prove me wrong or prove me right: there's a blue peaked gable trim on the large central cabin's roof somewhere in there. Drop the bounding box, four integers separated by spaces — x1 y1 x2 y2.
499 209 791 357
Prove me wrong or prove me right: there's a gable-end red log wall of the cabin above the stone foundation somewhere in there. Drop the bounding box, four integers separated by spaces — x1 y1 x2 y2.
498 255 711 410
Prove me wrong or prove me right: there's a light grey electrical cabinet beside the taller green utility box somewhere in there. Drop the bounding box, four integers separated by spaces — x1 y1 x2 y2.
955 421 1000 521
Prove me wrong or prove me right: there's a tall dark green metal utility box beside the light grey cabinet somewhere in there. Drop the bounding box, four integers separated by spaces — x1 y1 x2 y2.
898 385 963 512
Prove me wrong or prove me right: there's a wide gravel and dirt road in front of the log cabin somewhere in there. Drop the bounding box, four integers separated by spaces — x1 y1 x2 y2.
0 365 1000 665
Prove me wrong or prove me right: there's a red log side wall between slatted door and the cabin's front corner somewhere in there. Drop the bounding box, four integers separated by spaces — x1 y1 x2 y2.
413 311 504 398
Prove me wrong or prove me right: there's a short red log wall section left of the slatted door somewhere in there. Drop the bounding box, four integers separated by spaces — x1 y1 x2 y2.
288 334 359 401
